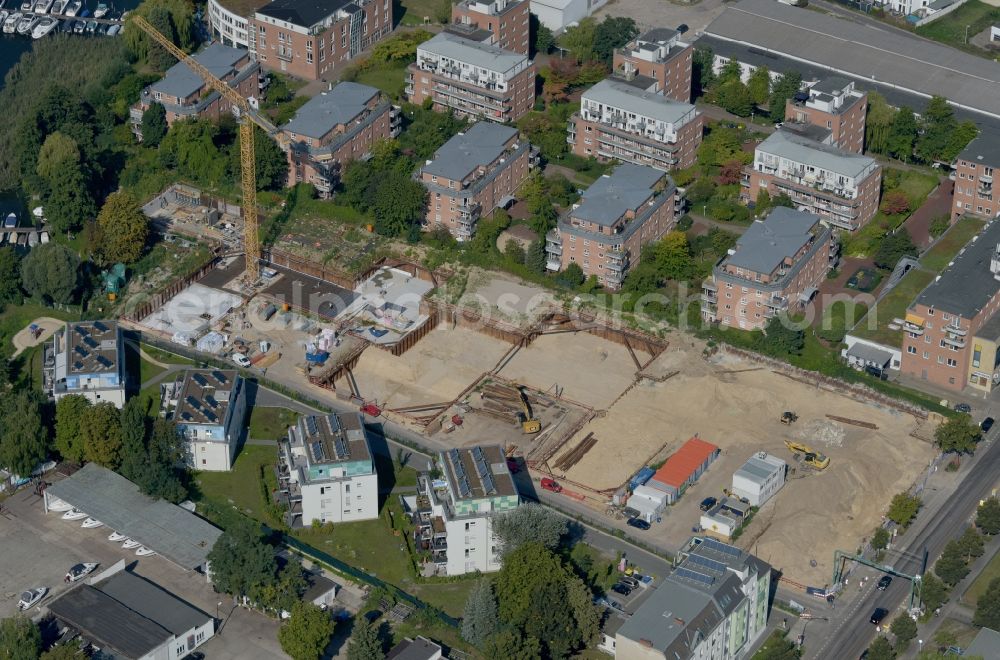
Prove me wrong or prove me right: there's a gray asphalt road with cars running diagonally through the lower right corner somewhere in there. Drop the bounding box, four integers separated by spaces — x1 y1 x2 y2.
806 432 1000 660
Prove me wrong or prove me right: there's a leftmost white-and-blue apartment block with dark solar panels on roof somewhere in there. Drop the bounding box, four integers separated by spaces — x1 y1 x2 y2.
42 321 126 408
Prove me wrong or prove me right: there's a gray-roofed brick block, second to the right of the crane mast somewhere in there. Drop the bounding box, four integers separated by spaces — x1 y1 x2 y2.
417 121 538 241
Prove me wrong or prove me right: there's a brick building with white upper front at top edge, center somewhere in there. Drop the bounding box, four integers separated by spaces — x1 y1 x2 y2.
448 0 529 55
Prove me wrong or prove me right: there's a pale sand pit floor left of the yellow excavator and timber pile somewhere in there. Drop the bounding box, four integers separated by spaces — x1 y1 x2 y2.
354 326 510 408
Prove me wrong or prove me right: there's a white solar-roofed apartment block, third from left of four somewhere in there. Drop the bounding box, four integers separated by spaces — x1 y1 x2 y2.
278 413 378 528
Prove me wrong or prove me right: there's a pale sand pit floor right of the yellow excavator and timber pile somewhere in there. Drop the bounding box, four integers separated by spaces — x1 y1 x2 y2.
500 332 648 408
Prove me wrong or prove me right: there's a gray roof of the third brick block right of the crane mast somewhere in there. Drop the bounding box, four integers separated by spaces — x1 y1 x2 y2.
570 163 664 226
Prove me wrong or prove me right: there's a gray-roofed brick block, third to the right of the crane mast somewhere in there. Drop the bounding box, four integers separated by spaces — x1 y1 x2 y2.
545 163 677 290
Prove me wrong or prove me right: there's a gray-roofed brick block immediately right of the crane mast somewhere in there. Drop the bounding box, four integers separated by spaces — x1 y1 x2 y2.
278 82 400 197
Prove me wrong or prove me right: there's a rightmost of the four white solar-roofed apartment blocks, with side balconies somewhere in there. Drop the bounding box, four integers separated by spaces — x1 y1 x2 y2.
414 445 521 575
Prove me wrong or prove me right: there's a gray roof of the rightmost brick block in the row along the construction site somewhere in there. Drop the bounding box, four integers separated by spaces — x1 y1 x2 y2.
723 206 820 273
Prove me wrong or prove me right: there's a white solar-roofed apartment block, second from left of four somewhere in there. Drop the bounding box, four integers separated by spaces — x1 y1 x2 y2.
160 369 247 472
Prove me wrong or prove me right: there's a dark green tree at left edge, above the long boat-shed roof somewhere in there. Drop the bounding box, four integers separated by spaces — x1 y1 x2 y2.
0 389 49 476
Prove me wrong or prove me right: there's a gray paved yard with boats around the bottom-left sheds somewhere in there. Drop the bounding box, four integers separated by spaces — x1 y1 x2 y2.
0 482 285 660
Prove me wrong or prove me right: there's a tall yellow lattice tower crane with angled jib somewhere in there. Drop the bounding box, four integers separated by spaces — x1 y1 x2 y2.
129 14 276 285
